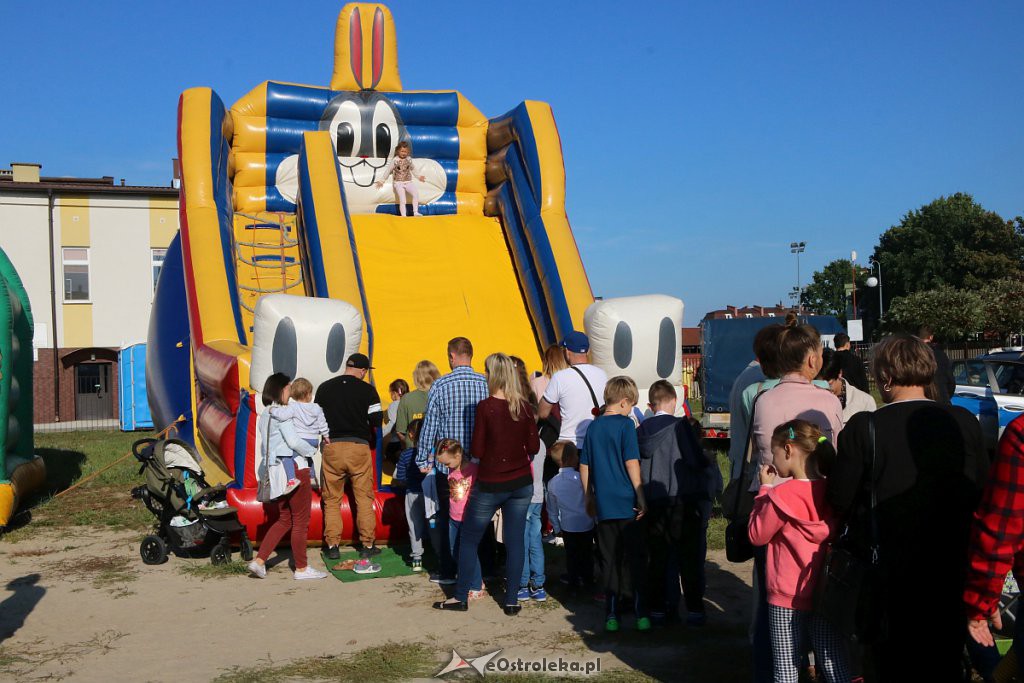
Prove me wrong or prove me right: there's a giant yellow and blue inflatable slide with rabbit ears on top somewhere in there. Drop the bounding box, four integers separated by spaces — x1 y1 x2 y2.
147 3 594 540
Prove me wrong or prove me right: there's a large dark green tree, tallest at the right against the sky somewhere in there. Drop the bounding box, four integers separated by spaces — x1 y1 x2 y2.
874 193 1024 300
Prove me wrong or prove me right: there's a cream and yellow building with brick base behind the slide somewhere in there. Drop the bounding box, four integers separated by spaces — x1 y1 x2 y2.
0 163 178 424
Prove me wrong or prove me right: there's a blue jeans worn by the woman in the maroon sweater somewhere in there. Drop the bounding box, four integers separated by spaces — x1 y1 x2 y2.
455 482 534 605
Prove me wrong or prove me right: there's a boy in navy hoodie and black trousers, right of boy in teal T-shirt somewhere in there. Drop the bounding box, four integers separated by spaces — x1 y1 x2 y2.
637 380 714 626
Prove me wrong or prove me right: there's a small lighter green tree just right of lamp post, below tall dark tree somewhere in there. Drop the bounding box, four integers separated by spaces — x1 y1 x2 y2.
886 285 986 341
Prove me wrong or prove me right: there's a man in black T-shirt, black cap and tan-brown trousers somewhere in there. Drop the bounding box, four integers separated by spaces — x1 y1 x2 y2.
315 353 383 573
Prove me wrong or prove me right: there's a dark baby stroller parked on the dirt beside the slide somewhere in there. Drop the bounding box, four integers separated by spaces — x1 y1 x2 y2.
131 438 253 564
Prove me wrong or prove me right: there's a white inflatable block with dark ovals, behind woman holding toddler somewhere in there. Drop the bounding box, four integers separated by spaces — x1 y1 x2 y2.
249 294 362 404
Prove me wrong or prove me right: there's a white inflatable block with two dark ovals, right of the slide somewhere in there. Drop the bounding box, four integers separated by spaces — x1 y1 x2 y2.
584 294 683 398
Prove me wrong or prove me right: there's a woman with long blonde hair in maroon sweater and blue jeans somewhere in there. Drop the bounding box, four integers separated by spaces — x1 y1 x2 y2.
434 353 541 616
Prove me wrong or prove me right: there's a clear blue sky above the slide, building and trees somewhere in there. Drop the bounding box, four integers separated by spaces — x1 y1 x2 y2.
0 0 1024 325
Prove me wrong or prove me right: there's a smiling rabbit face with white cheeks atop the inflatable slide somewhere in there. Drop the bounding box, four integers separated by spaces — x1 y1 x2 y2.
275 90 447 213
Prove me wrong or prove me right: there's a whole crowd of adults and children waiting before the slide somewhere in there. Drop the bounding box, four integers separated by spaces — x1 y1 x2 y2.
250 316 1024 683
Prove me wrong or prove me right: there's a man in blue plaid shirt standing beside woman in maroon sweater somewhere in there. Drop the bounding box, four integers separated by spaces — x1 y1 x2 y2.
416 337 487 585
